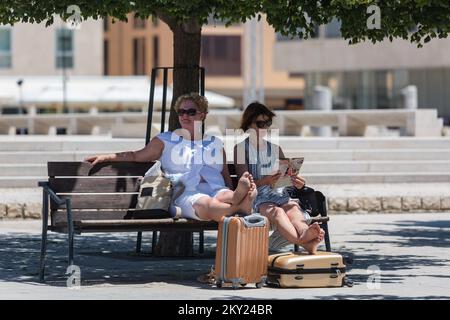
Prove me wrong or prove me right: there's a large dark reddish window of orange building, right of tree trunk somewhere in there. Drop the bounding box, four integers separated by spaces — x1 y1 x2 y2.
201 36 241 76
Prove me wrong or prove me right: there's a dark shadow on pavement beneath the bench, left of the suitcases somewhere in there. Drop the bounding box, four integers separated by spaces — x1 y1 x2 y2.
0 233 216 287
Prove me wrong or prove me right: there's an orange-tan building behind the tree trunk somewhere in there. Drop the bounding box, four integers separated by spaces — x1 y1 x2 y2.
104 15 304 108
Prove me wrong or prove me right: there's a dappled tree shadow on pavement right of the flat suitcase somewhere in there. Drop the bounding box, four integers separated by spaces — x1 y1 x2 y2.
338 220 450 283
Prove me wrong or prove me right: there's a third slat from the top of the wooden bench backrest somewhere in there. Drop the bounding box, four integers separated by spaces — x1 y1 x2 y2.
50 193 138 210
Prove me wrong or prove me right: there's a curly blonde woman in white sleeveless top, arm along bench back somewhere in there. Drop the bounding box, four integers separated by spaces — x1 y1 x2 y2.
85 93 257 221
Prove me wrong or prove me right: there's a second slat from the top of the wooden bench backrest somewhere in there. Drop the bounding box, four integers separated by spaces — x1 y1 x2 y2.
48 177 140 193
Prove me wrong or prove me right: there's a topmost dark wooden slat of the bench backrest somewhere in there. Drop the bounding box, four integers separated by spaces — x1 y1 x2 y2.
47 161 153 177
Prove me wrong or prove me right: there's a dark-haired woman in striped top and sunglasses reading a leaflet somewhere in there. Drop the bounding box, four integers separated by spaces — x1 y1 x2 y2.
234 102 325 253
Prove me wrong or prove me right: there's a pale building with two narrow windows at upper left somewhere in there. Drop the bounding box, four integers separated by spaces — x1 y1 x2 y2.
0 18 103 76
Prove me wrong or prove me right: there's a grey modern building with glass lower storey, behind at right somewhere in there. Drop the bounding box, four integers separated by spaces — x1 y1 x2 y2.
274 21 450 121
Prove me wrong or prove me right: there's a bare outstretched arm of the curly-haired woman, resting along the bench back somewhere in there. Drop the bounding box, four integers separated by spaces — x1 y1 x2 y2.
84 137 164 165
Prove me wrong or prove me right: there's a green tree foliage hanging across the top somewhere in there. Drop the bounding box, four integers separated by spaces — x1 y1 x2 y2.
0 0 450 46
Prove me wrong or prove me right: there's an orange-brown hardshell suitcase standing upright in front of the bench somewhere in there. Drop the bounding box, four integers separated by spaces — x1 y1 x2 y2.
215 214 269 289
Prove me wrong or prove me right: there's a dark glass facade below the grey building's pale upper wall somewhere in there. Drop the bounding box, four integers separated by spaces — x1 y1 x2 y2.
303 68 450 118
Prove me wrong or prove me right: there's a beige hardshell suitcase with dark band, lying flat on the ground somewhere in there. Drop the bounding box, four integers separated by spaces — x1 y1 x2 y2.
267 251 352 288
